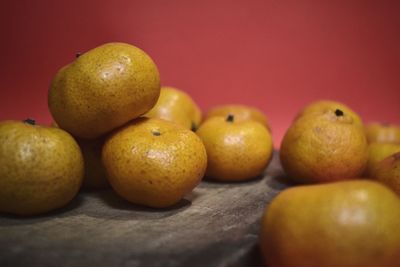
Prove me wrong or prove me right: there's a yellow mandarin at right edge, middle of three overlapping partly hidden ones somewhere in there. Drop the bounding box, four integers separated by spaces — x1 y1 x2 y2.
365 143 400 177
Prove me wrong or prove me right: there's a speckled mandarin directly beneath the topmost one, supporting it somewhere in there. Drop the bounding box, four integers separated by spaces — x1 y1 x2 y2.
102 118 207 208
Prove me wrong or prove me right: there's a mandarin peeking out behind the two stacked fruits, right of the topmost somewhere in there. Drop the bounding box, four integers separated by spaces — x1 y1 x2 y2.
144 86 201 130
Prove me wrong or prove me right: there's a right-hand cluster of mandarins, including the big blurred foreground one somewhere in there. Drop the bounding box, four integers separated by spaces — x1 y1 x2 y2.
260 101 400 267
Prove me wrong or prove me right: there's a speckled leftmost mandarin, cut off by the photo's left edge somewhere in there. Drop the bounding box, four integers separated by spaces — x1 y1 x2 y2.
0 121 84 215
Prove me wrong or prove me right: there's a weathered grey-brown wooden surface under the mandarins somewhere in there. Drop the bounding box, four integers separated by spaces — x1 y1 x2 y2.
0 154 288 267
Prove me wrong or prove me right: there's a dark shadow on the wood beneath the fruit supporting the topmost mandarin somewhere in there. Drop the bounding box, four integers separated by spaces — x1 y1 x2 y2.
81 190 194 220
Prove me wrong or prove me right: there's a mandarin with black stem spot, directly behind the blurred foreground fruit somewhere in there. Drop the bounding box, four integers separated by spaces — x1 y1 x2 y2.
280 110 368 183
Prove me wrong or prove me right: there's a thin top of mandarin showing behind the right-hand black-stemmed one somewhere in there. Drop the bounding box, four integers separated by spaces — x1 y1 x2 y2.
296 100 363 126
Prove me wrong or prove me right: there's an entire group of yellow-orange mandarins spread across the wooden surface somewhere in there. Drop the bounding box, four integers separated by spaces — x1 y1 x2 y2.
0 43 400 267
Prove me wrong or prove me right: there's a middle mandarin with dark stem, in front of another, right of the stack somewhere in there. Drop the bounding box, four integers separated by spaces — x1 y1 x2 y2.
196 115 273 181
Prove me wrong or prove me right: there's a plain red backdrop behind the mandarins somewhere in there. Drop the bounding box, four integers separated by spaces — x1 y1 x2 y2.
0 0 400 146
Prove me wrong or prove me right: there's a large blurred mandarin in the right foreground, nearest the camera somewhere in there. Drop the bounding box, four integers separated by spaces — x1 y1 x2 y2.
260 180 400 267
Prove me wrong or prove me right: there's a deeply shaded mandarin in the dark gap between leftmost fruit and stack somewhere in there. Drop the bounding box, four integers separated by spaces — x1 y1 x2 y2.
76 136 109 189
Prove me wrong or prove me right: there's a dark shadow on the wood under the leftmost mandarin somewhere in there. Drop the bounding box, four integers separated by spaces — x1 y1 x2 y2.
0 194 85 227
